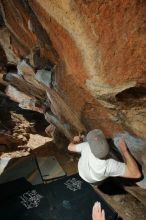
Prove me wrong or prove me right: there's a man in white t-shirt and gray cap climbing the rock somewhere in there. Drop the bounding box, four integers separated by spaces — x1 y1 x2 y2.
68 129 141 183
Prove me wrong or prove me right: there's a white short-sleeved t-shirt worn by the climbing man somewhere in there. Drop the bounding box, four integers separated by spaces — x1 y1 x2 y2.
76 142 125 183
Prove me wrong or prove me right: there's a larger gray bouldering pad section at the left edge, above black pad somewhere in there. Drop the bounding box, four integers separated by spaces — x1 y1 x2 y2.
0 156 43 185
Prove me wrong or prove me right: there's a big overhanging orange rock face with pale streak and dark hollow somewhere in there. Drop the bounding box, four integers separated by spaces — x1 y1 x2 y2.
29 0 146 138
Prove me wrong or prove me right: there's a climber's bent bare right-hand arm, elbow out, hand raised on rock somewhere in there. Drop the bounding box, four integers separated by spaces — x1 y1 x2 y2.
119 139 141 178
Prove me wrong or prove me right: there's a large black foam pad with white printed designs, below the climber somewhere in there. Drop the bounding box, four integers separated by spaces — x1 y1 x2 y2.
0 174 117 220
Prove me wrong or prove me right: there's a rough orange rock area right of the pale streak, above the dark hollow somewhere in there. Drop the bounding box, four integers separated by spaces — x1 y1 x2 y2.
75 0 146 85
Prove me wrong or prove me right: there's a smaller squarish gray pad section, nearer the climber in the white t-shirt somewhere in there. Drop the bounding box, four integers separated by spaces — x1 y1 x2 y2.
36 156 65 181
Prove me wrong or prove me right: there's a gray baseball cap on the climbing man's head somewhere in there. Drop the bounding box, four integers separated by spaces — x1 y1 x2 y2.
86 129 109 159
